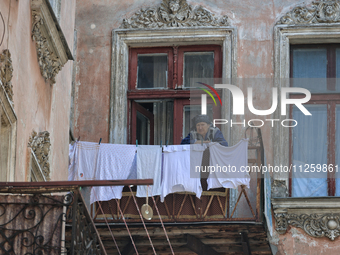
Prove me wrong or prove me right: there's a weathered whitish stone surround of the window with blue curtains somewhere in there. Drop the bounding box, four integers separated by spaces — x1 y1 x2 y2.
272 23 340 189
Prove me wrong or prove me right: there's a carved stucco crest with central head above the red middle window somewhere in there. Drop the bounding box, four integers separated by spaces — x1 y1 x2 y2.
120 0 229 28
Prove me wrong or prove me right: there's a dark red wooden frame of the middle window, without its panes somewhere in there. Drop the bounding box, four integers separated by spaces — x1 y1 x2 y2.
127 44 223 144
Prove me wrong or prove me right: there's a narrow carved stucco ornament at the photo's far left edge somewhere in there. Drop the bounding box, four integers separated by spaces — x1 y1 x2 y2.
0 49 13 105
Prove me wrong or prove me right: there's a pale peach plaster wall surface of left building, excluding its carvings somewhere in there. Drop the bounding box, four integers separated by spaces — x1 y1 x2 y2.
0 0 75 181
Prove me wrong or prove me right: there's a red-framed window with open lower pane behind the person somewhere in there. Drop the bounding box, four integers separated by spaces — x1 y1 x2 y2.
127 45 222 144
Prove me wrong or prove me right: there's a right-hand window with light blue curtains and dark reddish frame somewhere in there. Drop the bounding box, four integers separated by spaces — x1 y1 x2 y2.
290 44 340 197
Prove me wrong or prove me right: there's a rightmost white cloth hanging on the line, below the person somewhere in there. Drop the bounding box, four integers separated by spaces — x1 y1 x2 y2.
207 139 250 190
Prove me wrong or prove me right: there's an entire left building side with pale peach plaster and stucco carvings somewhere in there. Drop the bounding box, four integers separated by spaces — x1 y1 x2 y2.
0 0 75 181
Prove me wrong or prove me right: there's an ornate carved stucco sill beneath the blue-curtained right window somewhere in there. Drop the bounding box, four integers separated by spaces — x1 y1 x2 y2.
272 197 340 241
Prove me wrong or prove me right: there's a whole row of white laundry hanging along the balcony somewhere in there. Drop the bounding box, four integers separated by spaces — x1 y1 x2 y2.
69 139 250 203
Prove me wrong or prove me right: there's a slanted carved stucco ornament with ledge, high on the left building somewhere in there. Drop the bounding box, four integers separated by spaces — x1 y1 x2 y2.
31 0 73 84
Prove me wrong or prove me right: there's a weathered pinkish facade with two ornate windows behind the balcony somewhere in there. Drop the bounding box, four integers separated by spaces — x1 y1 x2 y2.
71 0 340 254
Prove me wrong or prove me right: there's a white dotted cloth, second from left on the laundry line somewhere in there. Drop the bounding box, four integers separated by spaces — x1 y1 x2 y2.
91 143 137 204
